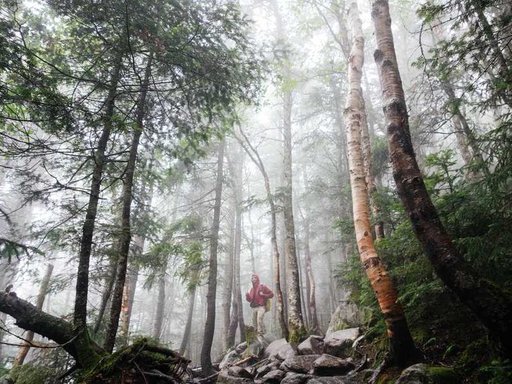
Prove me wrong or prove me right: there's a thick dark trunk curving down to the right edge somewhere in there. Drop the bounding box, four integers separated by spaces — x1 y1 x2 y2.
372 0 512 356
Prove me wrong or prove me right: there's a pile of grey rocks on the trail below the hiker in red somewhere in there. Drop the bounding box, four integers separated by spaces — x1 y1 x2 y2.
217 328 369 384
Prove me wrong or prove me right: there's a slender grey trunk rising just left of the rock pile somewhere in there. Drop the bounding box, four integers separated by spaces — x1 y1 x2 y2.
201 140 225 376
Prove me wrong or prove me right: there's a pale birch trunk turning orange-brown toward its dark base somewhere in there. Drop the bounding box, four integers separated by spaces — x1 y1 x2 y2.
345 3 418 366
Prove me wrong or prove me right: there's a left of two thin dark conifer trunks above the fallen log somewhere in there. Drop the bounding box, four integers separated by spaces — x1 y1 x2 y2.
73 52 123 330
